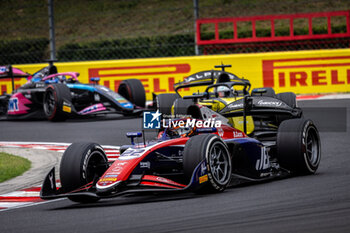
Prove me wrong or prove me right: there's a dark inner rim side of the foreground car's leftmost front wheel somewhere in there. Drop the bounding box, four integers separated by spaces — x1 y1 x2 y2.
85 151 108 183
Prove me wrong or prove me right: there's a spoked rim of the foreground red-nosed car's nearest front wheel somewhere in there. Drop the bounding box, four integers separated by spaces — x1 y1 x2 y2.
209 142 230 185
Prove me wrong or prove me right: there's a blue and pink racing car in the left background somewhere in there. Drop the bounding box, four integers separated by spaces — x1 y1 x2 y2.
0 65 146 121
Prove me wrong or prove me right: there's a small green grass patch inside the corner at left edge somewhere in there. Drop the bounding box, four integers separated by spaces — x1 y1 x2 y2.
0 152 31 183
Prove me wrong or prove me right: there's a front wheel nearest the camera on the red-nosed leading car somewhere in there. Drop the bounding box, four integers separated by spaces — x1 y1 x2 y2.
183 134 232 193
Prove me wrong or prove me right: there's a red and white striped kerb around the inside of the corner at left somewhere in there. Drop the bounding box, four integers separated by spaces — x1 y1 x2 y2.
0 141 119 211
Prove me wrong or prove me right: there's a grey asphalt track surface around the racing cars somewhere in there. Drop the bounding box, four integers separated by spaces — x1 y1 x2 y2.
0 100 350 233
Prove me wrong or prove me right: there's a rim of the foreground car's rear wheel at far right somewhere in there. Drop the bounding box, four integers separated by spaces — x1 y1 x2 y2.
306 128 320 166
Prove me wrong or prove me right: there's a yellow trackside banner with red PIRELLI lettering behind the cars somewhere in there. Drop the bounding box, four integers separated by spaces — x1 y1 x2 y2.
0 49 350 100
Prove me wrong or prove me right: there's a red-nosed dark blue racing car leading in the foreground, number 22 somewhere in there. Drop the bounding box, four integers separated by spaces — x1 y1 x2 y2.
41 105 321 203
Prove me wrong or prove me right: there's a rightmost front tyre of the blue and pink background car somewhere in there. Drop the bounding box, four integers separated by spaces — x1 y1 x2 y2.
118 79 146 108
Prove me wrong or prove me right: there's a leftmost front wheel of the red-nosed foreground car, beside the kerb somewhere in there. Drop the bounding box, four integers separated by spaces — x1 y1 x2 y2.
60 142 108 203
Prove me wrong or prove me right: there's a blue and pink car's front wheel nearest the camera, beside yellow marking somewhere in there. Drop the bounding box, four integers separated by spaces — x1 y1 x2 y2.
43 83 72 121
